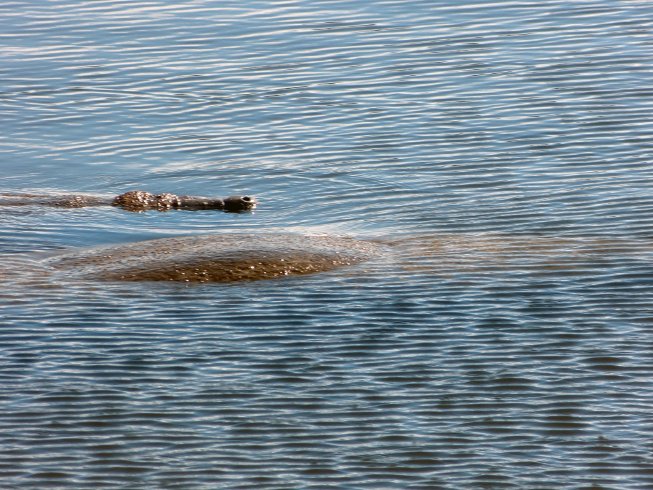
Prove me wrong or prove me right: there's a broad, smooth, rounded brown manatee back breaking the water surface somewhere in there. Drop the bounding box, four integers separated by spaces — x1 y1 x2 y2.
47 234 382 283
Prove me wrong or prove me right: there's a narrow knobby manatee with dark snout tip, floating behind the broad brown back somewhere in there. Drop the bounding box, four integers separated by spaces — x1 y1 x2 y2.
0 191 257 212
